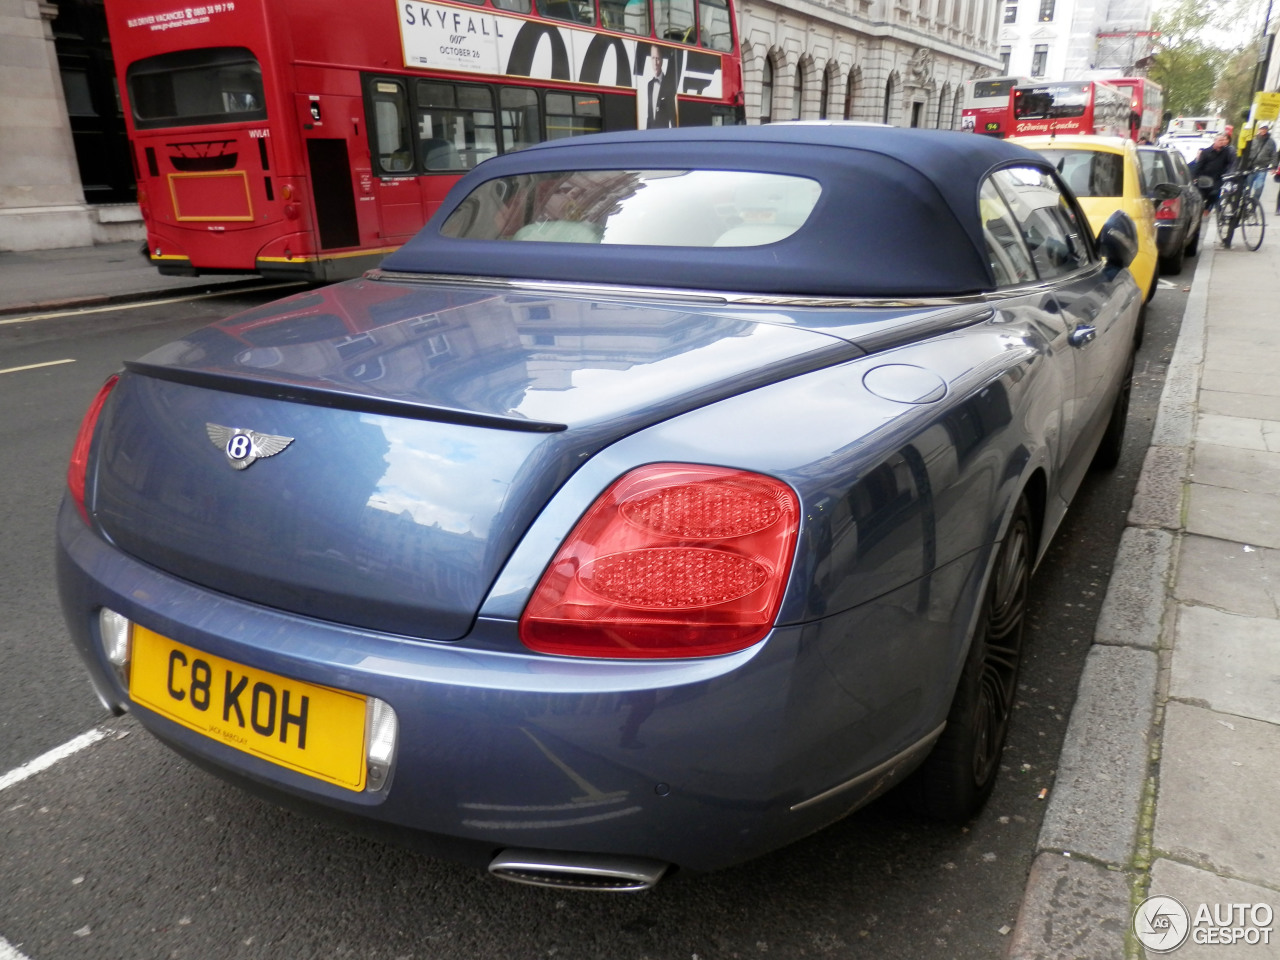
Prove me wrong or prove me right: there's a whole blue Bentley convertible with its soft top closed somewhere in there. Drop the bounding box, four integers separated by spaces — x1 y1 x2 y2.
58 124 1142 890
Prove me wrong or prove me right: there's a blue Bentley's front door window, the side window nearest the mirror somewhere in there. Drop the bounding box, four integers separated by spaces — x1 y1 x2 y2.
991 166 1091 280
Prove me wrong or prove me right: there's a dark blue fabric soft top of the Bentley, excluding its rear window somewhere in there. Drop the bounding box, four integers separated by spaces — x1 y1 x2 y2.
383 123 1052 297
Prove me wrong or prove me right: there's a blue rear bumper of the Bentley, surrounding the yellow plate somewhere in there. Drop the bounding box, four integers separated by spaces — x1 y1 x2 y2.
58 504 950 870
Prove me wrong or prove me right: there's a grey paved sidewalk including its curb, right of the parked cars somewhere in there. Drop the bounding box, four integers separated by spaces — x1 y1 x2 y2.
1009 207 1280 960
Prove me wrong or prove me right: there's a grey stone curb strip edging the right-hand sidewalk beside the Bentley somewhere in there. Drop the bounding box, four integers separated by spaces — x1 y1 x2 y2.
1007 242 1213 960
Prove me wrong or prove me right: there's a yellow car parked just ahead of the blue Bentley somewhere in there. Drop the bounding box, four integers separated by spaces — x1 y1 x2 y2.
1009 133 1160 300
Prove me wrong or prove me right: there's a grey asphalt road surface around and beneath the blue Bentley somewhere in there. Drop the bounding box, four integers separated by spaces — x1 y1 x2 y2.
0 272 1194 960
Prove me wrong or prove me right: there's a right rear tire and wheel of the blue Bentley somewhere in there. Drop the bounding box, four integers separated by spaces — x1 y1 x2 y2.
902 497 1034 823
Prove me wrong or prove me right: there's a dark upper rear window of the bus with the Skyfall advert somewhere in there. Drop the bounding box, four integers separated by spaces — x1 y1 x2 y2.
125 47 266 129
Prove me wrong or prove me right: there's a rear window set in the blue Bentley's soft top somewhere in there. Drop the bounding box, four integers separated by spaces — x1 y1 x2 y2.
440 170 822 247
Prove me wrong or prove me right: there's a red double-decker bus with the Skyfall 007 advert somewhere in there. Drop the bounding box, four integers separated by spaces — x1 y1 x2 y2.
106 0 742 282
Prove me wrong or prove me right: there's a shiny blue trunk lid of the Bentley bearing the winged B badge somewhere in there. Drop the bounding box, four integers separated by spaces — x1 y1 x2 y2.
90 282 860 640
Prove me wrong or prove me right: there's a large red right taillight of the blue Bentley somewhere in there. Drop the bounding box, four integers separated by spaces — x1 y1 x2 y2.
520 463 800 658
